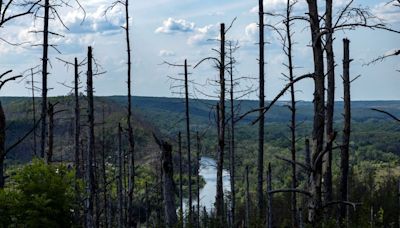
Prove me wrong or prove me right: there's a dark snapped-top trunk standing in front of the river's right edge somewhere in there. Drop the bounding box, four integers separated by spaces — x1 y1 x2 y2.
215 23 225 226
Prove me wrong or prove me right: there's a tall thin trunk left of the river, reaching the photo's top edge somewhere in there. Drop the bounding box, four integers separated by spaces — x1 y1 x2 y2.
124 0 135 227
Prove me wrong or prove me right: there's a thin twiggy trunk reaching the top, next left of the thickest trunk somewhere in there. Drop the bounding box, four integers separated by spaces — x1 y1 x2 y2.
285 0 298 227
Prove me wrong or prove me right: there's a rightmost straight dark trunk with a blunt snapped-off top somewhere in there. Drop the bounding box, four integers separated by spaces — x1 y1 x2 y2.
339 39 351 224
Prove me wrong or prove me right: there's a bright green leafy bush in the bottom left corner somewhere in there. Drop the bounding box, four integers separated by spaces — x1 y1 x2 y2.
0 159 76 227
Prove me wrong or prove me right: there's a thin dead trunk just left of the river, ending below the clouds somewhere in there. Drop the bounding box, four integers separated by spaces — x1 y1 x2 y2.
185 59 193 224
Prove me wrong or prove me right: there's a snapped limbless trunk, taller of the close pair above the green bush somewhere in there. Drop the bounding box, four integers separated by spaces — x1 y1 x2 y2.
86 47 96 227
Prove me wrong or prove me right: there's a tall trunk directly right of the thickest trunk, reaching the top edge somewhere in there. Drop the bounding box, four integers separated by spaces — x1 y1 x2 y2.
323 0 335 207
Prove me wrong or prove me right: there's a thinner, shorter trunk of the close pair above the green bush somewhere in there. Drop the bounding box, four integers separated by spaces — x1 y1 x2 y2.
74 58 83 179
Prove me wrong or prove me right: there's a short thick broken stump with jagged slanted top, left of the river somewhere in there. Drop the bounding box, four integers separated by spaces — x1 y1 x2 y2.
153 134 178 227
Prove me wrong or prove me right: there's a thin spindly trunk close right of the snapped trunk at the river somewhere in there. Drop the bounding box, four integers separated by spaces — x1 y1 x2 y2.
229 41 236 227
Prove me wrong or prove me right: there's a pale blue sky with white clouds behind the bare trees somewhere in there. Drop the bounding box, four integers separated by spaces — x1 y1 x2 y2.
0 0 400 101
